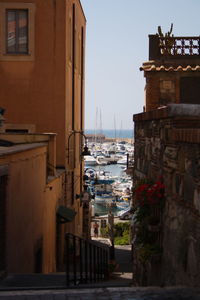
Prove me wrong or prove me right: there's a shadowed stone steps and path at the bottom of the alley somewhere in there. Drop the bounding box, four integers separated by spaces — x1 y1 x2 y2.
0 246 200 300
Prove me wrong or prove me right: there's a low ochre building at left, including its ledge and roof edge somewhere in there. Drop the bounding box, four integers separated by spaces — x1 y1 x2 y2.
0 133 65 277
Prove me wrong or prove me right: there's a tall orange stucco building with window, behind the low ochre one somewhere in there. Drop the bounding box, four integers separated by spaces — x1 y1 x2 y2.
0 0 88 241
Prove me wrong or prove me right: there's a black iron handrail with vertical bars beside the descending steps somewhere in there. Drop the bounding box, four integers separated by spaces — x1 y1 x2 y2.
65 233 109 286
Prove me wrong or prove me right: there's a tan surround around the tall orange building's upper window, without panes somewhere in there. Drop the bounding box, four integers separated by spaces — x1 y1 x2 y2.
0 2 35 61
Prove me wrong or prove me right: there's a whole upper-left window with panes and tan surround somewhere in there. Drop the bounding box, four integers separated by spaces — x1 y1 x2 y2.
0 2 35 61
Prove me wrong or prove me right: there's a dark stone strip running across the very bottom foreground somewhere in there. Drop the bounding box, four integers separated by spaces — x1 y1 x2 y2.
0 287 200 300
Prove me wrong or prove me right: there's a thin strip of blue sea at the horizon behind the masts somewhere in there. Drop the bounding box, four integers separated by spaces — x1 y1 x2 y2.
85 128 134 139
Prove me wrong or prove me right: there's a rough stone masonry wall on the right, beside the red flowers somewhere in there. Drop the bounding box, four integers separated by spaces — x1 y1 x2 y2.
134 104 200 286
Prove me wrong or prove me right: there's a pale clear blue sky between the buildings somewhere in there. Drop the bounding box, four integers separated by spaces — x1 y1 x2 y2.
81 0 200 129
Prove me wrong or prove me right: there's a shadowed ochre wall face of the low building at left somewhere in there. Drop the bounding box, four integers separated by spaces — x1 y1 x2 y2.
0 146 63 273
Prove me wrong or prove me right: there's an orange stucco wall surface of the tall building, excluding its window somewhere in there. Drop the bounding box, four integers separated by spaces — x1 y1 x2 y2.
0 0 86 235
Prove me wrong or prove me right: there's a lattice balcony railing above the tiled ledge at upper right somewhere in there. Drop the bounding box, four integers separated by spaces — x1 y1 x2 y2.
149 35 200 60
